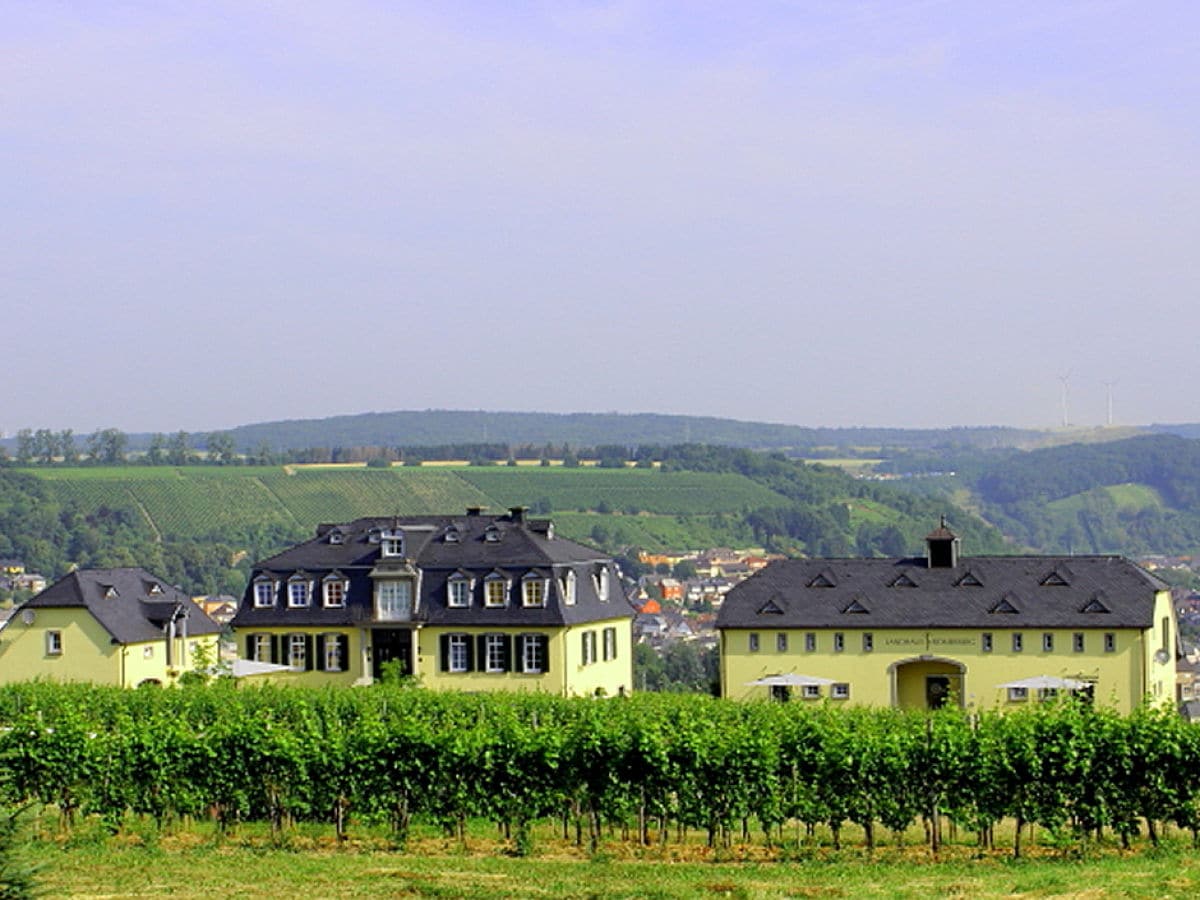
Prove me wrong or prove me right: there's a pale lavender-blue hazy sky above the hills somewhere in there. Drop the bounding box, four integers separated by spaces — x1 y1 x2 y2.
0 0 1200 434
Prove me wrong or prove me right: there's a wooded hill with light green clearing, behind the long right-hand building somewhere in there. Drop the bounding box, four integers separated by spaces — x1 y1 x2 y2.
966 434 1200 554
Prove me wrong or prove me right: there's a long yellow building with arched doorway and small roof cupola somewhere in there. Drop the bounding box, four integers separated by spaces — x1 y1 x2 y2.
716 521 1177 712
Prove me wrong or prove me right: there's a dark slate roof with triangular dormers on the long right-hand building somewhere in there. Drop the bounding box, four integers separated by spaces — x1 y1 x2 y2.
716 557 1168 630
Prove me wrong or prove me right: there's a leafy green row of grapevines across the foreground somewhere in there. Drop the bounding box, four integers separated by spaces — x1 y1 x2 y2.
0 679 1200 854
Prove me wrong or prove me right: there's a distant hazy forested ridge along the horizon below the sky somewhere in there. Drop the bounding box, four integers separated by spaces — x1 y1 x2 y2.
223 409 1043 451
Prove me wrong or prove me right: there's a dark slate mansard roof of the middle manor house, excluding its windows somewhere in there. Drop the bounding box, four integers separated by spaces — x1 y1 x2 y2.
233 512 634 629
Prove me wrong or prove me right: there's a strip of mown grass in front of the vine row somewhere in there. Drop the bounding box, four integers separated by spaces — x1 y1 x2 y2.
28 835 1200 900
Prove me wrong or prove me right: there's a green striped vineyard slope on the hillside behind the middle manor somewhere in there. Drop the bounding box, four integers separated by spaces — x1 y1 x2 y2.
31 466 786 548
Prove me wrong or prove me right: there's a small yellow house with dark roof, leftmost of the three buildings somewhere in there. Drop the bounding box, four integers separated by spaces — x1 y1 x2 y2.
0 568 220 688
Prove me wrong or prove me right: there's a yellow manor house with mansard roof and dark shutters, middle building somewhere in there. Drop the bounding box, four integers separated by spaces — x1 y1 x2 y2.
232 506 634 696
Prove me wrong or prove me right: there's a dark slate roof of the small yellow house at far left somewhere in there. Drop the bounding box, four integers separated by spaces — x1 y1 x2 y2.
22 569 221 643
